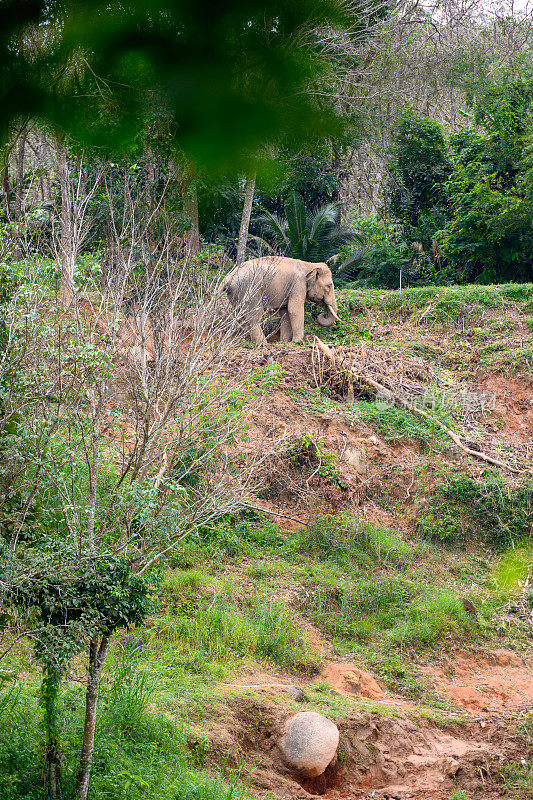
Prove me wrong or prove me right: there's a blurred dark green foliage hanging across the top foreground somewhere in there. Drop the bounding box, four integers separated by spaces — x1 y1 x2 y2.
0 0 357 175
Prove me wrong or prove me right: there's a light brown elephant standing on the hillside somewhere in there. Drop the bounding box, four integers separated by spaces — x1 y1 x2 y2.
223 256 340 344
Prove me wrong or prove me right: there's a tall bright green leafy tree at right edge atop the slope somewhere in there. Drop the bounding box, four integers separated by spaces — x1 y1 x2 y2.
443 76 533 283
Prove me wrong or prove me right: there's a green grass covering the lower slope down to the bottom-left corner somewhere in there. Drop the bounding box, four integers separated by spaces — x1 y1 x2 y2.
0 506 522 800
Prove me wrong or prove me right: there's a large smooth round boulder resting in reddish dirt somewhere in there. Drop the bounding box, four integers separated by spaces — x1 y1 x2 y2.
280 711 339 778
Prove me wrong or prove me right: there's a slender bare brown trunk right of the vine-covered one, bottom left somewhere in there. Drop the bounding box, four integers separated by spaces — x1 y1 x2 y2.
76 633 111 800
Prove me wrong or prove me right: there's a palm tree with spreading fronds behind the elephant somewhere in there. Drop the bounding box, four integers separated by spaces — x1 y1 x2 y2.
259 192 360 262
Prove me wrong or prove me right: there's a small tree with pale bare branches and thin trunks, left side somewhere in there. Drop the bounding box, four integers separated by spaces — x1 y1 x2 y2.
0 181 278 800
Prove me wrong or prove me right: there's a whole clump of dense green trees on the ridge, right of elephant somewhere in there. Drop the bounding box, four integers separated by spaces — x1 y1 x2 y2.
370 74 533 286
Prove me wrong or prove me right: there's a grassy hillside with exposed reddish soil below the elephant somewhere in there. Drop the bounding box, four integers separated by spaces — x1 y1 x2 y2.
0 284 533 800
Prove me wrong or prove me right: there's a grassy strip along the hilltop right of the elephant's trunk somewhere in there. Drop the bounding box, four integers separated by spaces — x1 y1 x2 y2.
306 284 533 376
